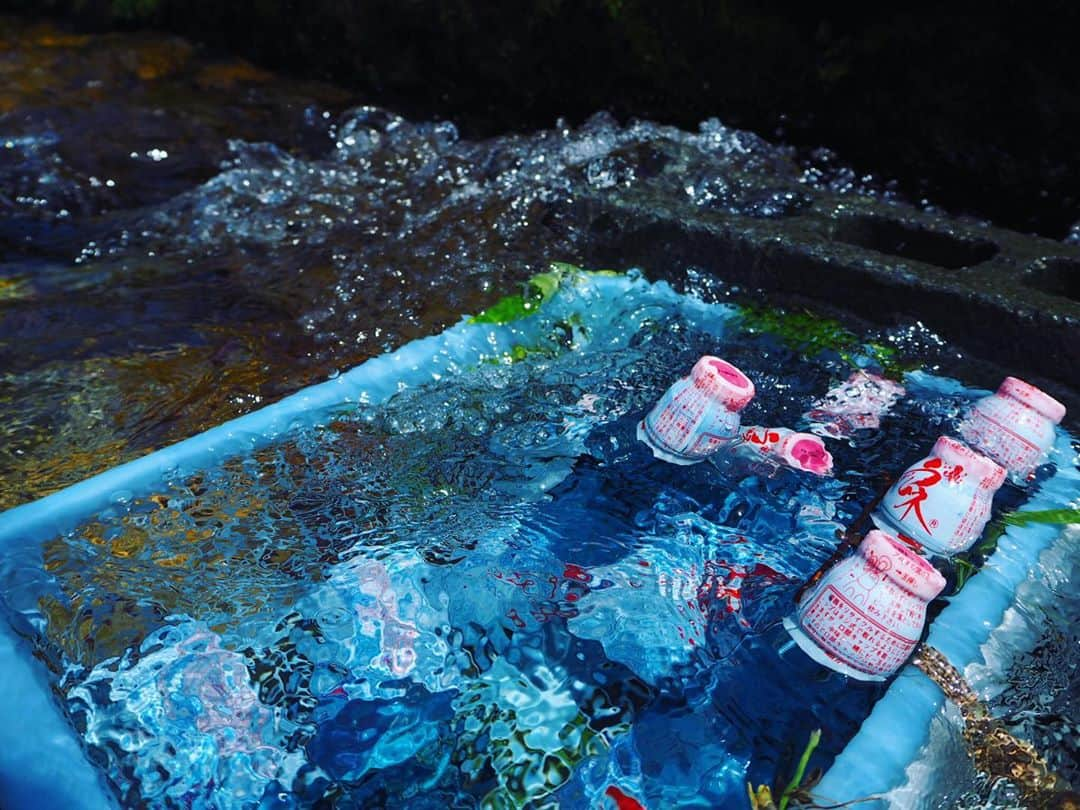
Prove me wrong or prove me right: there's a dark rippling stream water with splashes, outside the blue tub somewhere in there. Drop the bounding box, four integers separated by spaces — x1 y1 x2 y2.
0 12 902 507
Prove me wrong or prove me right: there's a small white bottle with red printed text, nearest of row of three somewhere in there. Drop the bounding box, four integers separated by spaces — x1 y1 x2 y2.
784 529 945 680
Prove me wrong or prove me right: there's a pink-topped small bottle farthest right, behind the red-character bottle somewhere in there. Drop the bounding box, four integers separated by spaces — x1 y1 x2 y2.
960 377 1065 482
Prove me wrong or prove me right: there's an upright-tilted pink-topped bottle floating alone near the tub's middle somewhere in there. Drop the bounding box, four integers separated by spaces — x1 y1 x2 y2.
637 354 754 464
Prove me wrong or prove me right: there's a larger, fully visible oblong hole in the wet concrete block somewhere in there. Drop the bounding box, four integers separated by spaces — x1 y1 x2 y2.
833 216 998 270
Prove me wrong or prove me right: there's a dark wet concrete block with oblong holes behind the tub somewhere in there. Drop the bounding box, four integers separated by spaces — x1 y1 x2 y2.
579 193 1080 426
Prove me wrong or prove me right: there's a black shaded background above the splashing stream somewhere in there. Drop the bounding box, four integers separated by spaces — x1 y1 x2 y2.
6 0 1080 239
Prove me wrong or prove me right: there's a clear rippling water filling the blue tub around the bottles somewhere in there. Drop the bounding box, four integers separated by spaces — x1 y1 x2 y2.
3 276 1054 808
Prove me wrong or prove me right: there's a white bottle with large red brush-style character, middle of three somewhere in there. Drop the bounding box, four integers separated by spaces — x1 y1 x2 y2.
873 436 1005 554
